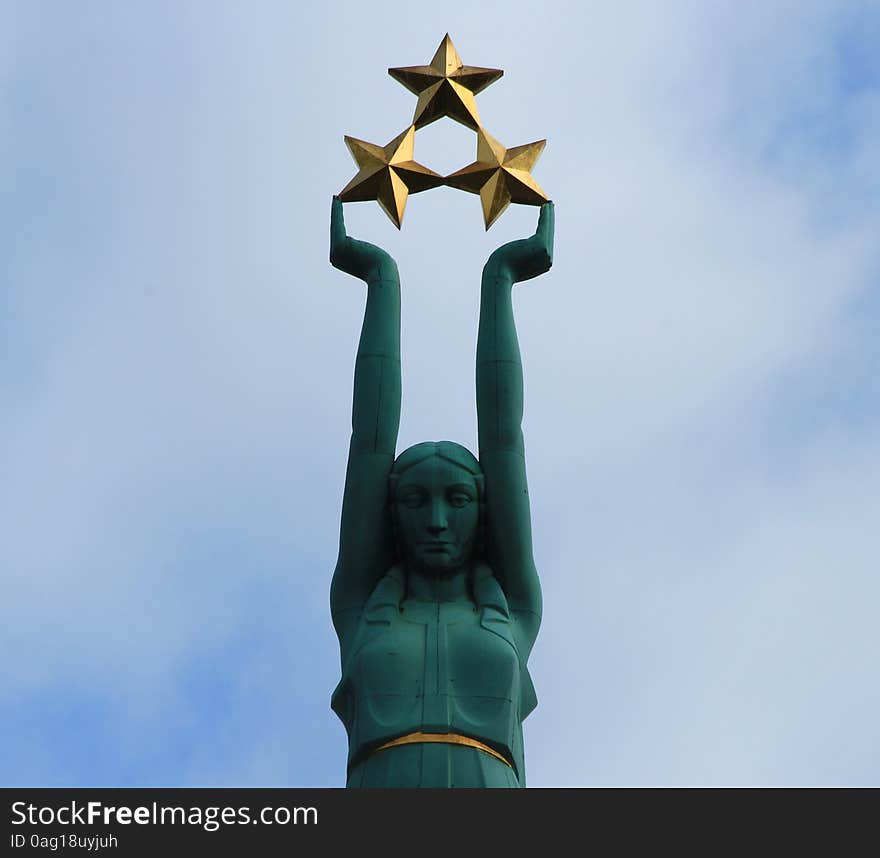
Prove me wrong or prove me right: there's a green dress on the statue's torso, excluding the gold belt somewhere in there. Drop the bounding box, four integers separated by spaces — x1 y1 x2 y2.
332 564 536 787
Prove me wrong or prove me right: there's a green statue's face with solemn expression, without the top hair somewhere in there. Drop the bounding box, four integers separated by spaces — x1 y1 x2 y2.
393 456 480 574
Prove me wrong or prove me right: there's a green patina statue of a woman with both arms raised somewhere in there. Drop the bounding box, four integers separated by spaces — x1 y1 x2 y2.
330 197 554 787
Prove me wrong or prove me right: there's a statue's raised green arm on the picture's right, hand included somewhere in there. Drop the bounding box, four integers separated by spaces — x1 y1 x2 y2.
477 203 554 643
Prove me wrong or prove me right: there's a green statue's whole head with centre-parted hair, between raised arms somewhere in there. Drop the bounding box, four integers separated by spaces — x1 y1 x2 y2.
389 441 484 574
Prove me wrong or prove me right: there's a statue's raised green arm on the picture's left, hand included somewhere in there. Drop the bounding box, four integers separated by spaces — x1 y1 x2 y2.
330 197 400 637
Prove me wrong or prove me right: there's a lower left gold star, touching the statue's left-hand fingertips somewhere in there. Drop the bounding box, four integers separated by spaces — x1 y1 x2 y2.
339 125 444 229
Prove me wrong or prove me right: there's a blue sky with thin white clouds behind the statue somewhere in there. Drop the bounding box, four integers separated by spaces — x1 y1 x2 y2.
0 0 880 787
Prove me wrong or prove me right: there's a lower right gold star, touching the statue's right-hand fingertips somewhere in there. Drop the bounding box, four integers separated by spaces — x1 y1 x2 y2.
446 128 549 229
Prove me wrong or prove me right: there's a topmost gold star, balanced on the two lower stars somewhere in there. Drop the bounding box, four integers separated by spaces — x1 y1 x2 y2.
388 33 504 131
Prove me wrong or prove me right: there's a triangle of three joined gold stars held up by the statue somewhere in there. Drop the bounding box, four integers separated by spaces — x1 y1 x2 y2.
339 34 549 229
